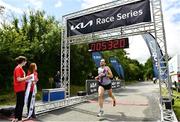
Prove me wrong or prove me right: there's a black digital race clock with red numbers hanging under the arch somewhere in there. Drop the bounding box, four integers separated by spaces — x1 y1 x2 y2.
89 38 129 51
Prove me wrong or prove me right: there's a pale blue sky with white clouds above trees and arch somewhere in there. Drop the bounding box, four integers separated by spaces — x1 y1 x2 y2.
0 0 180 64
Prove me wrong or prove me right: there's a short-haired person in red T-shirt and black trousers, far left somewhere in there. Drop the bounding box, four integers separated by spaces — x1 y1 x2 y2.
13 56 31 122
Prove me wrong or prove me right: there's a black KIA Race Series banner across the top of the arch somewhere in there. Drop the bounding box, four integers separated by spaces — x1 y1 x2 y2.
67 0 151 37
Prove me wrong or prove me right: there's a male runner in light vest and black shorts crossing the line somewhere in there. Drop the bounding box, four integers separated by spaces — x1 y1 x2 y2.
95 59 116 117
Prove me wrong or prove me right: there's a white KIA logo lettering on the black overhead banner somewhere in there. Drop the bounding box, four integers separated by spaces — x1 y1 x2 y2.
71 20 93 30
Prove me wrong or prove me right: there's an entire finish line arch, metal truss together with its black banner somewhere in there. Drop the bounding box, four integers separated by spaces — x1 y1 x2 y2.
61 0 174 121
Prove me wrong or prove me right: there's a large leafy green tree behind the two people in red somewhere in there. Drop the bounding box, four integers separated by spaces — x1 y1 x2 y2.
0 11 61 89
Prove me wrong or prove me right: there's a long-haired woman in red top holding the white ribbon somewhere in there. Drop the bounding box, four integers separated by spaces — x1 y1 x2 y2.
27 63 38 118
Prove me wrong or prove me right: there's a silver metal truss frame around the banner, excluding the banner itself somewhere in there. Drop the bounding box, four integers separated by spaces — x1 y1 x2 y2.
61 0 175 121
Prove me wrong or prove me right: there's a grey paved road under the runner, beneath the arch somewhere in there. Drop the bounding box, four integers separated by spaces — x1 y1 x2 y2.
37 82 160 122
